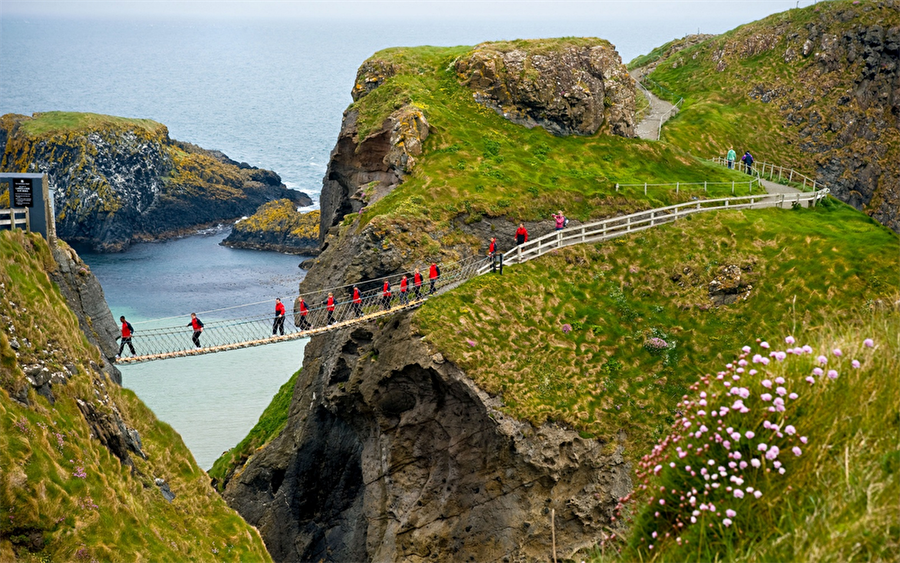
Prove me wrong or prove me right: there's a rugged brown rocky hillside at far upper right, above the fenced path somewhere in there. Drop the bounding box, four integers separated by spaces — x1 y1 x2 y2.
704 0 900 232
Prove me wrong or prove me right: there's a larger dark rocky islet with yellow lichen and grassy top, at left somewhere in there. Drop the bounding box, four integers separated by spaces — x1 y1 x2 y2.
0 112 311 251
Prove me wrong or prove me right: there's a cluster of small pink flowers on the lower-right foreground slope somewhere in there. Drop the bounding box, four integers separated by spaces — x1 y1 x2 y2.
601 336 874 550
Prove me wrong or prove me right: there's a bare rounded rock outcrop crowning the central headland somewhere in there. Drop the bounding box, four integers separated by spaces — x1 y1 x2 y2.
456 40 634 137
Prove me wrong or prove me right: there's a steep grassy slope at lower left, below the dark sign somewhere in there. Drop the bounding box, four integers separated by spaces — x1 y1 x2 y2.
0 231 270 561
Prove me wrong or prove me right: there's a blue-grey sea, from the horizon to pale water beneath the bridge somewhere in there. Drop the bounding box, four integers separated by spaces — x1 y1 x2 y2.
0 6 808 469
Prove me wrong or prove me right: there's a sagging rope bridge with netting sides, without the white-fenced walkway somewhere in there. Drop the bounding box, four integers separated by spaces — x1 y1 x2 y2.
116 253 491 364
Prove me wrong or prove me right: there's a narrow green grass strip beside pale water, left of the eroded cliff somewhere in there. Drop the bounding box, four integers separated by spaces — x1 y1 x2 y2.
209 370 300 489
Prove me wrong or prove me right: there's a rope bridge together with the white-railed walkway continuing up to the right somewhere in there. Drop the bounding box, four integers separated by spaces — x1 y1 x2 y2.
116 162 829 364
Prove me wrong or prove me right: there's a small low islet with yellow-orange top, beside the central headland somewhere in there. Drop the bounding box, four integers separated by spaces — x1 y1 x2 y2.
221 199 319 256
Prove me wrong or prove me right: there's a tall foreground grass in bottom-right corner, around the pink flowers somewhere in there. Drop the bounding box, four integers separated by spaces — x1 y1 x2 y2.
587 316 900 563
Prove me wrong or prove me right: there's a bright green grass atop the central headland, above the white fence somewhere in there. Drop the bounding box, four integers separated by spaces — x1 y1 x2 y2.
354 39 760 235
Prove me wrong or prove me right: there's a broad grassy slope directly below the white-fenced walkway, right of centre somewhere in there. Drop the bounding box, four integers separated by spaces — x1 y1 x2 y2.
415 200 900 456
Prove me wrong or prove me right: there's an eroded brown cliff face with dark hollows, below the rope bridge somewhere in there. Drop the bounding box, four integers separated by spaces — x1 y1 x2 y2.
224 314 631 562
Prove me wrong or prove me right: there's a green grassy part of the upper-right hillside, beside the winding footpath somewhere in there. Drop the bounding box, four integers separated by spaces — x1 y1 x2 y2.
651 0 900 174
